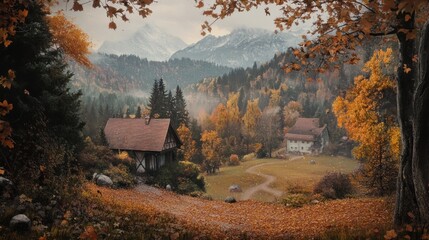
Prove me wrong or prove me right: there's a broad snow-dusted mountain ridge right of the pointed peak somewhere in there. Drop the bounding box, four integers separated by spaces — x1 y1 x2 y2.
171 28 301 67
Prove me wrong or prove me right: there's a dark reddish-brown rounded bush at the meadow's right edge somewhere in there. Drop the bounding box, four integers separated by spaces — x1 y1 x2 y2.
313 173 352 199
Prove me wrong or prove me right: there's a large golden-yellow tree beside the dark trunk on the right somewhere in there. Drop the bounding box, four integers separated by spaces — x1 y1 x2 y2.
332 49 400 195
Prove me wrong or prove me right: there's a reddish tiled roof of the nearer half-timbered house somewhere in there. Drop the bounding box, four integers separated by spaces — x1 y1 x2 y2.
104 118 170 152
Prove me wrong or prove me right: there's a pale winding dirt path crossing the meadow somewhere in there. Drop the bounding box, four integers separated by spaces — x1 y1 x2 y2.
240 156 304 200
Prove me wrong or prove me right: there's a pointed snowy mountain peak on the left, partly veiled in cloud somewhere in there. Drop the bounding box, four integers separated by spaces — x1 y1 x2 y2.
98 24 187 61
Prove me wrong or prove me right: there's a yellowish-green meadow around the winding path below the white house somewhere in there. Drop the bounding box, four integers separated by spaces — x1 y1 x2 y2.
205 156 358 202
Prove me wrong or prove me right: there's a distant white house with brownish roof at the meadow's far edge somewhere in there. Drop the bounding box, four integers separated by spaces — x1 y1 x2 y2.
285 118 329 154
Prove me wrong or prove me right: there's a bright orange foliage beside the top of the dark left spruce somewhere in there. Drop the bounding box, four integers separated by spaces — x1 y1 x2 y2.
47 12 91 67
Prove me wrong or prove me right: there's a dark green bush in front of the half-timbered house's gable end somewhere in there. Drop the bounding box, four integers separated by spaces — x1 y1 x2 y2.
153 161 205 194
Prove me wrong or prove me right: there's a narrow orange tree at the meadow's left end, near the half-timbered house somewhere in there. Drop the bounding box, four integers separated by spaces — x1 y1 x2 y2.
201 131 222 173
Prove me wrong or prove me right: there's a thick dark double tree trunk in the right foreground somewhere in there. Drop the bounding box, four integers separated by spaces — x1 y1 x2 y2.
394 16 429 225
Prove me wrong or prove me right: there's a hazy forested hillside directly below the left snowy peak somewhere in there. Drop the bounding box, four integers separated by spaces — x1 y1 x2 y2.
70 54 231 94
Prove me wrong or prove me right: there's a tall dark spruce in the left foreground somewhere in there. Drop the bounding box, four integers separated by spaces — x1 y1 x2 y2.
0 2 83 185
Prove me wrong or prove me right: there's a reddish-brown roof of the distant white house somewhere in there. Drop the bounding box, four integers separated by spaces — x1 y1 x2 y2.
285 118 326 141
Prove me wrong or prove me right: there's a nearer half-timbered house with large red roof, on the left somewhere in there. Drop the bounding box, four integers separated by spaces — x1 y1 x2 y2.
104 118 181 172
